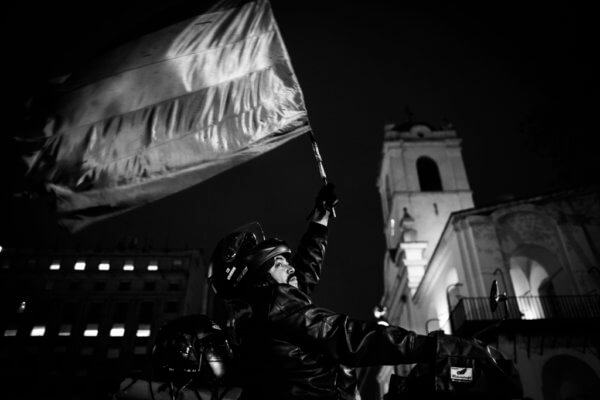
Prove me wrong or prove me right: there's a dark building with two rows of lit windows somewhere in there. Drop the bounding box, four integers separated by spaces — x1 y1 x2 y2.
0 248 210 399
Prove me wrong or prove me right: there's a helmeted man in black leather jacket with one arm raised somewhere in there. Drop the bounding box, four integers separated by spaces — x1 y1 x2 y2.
210 184 435 400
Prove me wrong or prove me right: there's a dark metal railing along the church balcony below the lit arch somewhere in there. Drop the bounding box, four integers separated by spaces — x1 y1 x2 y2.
450 295 600 330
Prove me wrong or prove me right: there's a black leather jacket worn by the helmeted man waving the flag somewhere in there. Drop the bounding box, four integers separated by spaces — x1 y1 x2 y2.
238 222 434 400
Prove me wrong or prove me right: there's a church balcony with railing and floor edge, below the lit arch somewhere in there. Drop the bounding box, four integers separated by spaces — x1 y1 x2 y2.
450 295 600 336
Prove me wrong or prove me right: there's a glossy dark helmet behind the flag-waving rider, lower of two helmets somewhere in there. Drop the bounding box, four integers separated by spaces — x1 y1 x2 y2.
152 314 233 384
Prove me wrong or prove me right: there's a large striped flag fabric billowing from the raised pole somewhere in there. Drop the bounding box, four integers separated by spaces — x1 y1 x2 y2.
19 0 310 231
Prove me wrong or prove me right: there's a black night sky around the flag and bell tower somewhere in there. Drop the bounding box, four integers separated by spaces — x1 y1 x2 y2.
0 0 598 318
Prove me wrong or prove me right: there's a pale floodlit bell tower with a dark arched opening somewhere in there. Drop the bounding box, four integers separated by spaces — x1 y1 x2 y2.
377 122 473 297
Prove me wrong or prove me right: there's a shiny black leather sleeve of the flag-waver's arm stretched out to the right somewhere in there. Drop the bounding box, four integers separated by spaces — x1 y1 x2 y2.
271 290 435 367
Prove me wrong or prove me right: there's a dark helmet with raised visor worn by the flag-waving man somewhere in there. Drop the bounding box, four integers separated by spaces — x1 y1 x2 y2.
209 224 292 298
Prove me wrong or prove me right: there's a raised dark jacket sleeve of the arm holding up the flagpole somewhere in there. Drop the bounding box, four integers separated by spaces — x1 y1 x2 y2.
292 222 328 295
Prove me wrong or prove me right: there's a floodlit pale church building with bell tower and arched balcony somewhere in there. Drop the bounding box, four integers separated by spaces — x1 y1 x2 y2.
362 124 600 400
